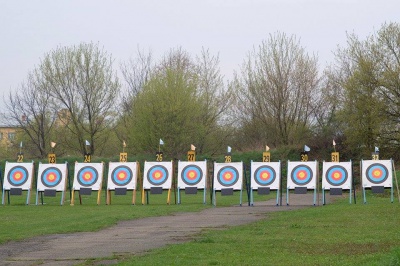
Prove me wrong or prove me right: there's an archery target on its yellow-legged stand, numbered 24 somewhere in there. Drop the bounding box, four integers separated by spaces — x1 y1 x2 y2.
71 162 104 206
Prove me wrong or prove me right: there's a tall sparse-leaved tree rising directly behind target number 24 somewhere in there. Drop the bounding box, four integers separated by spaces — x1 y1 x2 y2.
38 43 120 154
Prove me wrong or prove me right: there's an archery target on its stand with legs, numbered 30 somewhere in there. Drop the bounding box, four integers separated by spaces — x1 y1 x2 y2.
286 161 318 206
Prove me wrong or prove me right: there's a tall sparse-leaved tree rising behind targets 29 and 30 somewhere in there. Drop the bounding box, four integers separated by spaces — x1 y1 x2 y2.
232 33 319 149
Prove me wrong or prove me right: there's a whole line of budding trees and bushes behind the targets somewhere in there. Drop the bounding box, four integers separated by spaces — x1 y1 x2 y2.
2 23 400 160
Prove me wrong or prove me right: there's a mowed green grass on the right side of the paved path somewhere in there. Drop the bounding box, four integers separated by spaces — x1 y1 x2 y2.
120 194 400 265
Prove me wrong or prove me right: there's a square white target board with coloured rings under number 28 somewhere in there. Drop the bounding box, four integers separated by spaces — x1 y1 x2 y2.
214 162 243 191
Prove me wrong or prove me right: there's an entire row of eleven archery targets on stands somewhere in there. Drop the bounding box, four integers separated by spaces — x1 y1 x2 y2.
2 147 395 205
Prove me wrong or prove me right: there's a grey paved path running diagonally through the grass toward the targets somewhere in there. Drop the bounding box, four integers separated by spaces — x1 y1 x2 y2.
0 194 326 265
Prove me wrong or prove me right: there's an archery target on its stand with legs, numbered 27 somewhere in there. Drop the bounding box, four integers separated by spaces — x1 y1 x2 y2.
178 160 207 204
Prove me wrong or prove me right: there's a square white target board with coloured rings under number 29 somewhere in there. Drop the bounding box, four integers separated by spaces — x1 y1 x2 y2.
251 161 281 190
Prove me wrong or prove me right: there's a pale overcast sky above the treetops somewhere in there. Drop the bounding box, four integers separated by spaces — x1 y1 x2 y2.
0 0 400 109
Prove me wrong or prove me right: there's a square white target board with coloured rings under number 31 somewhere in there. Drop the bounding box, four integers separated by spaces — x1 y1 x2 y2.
322 161 353 190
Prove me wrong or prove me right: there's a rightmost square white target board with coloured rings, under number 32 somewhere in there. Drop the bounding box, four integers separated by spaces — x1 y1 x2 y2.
361 160 393 188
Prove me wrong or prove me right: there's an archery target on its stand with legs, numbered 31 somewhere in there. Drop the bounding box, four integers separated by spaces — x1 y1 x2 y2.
322 161 353 205
